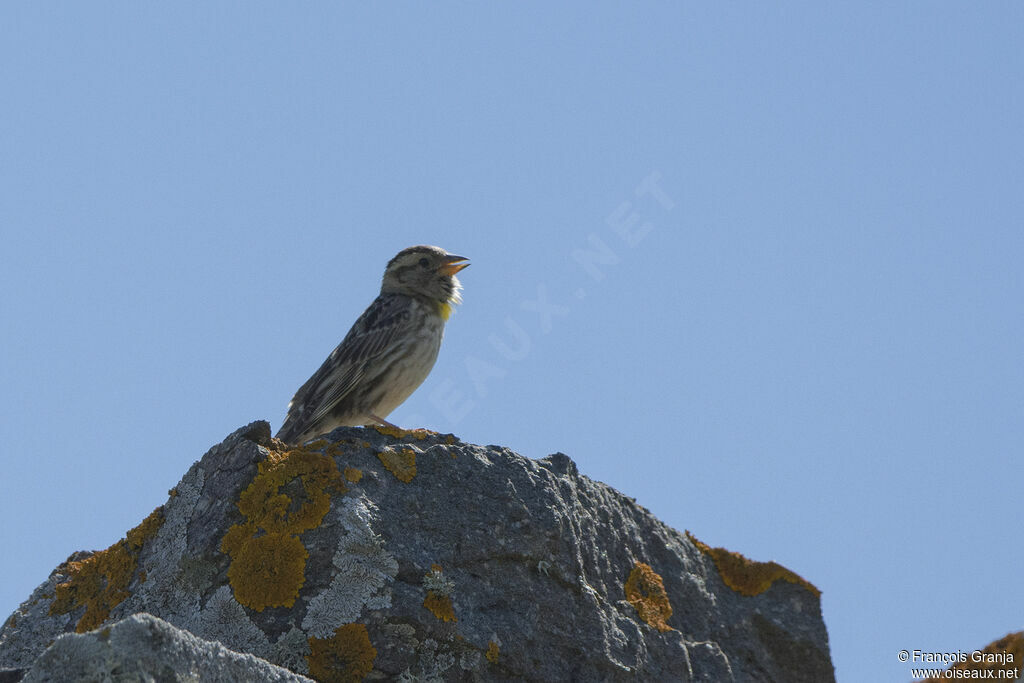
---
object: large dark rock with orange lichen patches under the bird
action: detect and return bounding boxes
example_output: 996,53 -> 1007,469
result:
0,422 -> 834,683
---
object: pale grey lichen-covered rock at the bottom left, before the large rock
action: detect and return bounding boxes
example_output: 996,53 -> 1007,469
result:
23,613 -> 310,683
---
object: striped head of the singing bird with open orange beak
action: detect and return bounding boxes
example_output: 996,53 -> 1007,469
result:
381,245 -> 469,317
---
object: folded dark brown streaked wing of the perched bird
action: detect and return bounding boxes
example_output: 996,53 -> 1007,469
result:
280,295 -> 413,440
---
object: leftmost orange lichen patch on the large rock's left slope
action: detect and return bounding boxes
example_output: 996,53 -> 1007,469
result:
49,507 -> 164,633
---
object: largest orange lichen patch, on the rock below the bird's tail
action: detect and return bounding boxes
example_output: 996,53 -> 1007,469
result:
220,441 -> 346,611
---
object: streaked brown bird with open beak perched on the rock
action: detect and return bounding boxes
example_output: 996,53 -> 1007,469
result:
276,245 -> 469,443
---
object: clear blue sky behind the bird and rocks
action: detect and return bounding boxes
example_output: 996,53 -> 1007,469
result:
0,1 -> 1024,682
